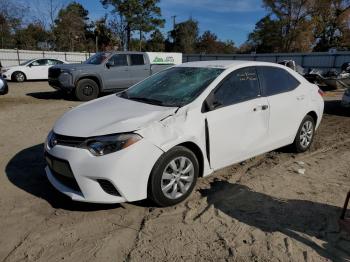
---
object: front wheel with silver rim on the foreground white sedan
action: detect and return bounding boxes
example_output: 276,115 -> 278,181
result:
148,146 -> 199,207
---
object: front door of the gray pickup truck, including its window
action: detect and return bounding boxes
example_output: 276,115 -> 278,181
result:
102,54 -> 130,89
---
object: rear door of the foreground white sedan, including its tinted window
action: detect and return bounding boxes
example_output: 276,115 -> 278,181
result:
258,66 -> 307,149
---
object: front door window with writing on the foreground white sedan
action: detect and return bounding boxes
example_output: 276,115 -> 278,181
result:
214,67 -> 260,106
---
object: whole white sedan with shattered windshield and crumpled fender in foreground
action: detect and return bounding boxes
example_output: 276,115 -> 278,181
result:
45,61 -> 324,206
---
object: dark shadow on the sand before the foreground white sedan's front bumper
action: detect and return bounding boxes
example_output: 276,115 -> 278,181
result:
5,144 -> 121,211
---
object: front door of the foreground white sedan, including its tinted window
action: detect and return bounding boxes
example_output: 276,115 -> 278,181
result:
205,67 -> 269,169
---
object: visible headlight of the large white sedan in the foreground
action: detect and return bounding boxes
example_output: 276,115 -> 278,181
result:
86,133 -> 142,156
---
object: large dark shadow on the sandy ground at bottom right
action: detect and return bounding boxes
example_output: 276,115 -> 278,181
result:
200,180 -> 350,261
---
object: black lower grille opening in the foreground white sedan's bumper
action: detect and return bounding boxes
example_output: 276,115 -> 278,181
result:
45,153 -> 81,192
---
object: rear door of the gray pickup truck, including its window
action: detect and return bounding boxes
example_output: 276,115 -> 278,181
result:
129,54 -> 151,85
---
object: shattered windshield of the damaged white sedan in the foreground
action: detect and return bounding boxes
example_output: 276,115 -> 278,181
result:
120,67 -> 224,107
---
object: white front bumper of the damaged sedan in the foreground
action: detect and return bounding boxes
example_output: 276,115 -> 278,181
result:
45,139 -> 163,203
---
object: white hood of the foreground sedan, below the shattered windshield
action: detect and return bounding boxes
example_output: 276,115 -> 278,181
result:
53,94 -> 177,137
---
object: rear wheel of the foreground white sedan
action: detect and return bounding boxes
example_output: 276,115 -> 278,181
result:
292,115 -> 315,153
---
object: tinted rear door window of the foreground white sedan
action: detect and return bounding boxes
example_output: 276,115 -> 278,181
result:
258,66 -> 300,96
